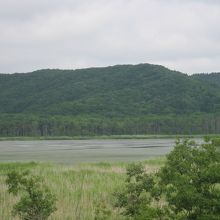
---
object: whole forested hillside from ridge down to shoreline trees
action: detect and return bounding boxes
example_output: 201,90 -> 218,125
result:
0,64 -> 220,136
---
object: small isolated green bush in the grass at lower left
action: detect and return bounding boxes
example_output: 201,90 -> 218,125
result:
6,171 -> 56,220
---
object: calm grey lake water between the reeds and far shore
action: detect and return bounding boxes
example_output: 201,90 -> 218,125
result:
0,139 -> 179,163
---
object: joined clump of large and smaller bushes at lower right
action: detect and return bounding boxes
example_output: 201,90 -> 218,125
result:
116,138 -> 220,220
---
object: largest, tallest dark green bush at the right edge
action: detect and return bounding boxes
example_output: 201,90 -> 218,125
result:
160,139 -> 220,219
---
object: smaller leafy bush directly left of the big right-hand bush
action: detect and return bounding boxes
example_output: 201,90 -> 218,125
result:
115,163 -> 166,220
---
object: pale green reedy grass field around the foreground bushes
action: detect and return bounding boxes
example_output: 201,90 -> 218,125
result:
0,157 -> 165,220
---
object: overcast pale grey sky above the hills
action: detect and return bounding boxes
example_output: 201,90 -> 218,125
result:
0,0 -> 220,74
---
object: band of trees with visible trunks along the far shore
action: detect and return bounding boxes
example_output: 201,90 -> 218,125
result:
0,114 -> 220,137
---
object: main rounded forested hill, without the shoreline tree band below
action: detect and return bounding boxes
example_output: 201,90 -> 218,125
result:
0,64 -> 220,116
